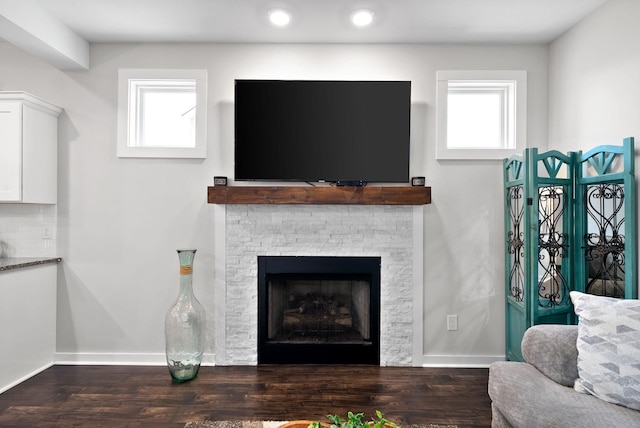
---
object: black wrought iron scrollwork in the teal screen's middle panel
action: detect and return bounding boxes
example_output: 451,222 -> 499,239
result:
538,186 -> 569,308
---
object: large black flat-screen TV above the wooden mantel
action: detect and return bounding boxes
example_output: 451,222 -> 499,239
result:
235,80 -> 411,183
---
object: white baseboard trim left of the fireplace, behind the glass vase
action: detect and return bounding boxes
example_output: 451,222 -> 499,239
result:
54,352 -> 215,366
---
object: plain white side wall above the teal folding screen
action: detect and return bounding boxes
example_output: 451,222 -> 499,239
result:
549,0 -> 640,300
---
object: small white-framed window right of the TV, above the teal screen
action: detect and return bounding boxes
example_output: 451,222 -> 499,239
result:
436,70 -> 527,159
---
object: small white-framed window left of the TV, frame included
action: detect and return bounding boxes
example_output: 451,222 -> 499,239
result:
118,69 -> 207,158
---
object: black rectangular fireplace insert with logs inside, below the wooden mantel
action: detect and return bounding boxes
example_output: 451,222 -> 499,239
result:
258,256 -> 381,365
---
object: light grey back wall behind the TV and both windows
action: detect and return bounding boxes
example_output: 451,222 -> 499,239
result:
0,43 -> 548,364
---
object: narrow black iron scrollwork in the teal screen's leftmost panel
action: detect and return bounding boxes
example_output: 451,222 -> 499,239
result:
507,186 -> 525,302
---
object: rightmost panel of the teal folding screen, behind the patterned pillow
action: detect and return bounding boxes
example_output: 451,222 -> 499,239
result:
575,142 -> 638,299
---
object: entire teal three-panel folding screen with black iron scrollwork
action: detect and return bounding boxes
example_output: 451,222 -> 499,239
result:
503,138 -> 637,361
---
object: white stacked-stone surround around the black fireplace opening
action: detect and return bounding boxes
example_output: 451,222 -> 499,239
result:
212,205 -> 423,366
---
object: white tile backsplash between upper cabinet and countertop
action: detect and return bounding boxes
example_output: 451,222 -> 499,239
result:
0,204 -> 58,257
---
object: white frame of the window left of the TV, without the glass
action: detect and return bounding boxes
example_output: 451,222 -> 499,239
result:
117,68 -> 207,159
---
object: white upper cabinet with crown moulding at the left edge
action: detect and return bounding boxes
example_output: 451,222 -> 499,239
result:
0,92 -> 62,204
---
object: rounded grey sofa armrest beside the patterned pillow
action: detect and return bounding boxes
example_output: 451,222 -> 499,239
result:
522,324 -> 578,387
